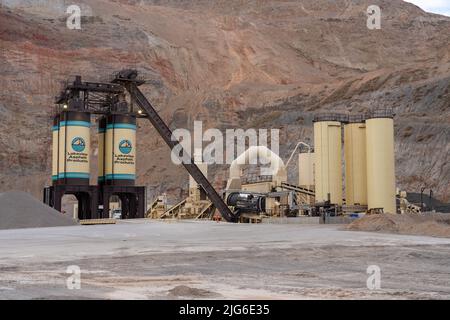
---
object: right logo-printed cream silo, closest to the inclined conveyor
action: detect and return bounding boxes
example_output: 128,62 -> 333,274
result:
104,114 -> 136,186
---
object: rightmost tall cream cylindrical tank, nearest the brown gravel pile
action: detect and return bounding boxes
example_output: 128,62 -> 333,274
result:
366,110 -> 397,213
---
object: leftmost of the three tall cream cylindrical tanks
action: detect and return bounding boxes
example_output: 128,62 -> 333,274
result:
314,114 -> 347,205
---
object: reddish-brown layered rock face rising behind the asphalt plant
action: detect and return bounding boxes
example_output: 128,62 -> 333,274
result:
0,0 -> 450,201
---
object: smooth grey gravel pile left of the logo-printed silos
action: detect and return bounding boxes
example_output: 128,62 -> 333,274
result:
0,191 -> 78,229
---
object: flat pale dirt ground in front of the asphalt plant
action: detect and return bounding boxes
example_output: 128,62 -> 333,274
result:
0,220 -> 450,299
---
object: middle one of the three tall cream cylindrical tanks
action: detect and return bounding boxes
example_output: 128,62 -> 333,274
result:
344,115 -> 367,205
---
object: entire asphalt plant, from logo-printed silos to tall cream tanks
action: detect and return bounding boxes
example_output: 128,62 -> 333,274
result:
44,70 -> 397,222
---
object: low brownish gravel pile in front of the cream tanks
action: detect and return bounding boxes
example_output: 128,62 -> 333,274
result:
347,213 -> 450,238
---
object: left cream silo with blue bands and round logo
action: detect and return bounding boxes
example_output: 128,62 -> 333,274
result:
57,111 -> 91,185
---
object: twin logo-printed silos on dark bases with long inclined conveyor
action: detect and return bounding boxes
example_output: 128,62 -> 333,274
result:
44,69 -> 236,222
